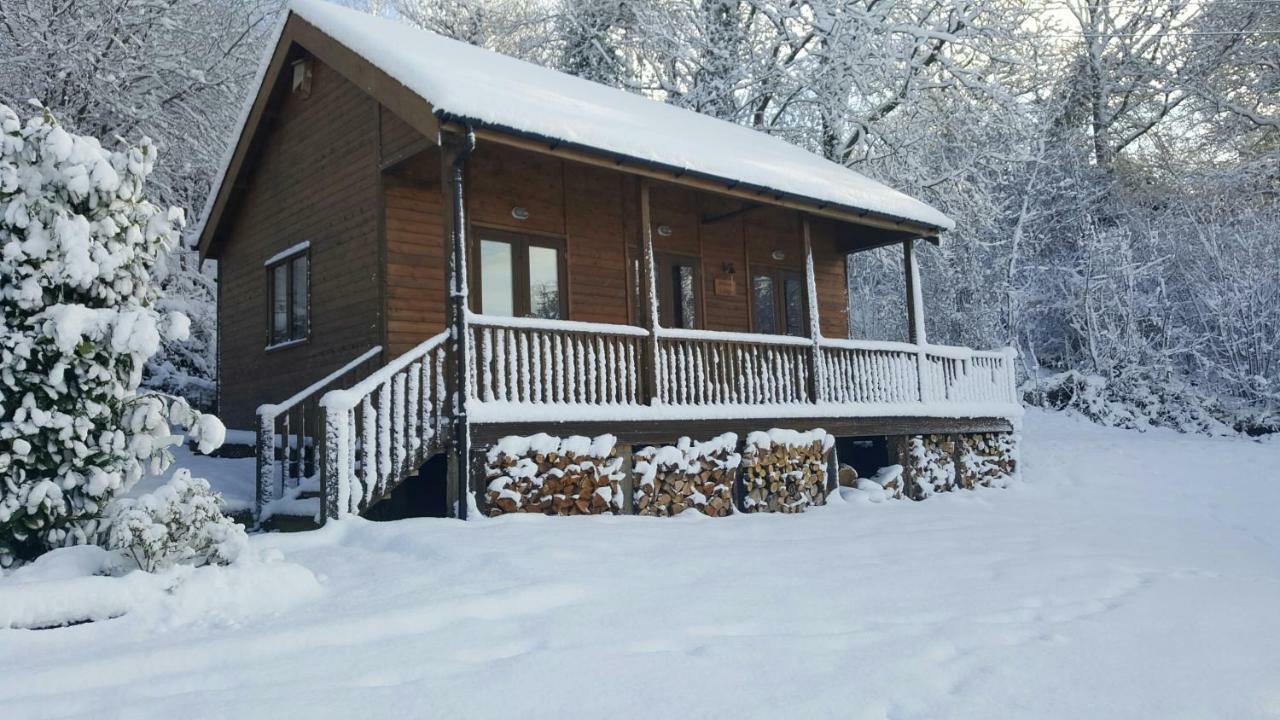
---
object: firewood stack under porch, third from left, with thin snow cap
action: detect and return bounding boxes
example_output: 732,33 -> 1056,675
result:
741,429 -> 836,512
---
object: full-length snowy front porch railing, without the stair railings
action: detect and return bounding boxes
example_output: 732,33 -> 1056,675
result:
470,315 -> 1018,419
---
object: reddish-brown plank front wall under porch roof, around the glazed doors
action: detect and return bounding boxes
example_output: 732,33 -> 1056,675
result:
467,143 -> 847,337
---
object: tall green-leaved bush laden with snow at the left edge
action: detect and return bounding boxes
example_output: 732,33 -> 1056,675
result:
0,105 -> 221,565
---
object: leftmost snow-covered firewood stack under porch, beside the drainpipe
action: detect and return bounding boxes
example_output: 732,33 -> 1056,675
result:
484,433 -> 622,516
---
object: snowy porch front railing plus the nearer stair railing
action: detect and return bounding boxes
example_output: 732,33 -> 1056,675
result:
303,315 -> 1018,519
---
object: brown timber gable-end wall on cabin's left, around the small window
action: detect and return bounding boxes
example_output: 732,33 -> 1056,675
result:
218,61 -> 381,428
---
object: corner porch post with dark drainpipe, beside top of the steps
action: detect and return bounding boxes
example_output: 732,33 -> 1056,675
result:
449,126 -> 476,520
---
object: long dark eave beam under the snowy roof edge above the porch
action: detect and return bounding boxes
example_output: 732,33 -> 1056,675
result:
442,122 -> 938,237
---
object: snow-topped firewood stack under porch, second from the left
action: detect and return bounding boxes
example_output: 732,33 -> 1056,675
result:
635,433 -> 741,518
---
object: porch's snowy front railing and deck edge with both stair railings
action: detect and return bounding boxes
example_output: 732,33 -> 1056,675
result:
249,307 -> 1020,519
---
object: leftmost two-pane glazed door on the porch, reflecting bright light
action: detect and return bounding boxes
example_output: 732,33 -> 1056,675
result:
474,228 -> 568,320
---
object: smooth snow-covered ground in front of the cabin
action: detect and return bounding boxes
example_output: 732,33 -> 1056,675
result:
0,413 -> 1280,720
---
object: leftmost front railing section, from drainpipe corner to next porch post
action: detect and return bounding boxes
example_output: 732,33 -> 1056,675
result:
468,315 -> 649,405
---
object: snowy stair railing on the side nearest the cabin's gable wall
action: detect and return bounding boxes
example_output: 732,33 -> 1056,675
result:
253,346 -> 383,520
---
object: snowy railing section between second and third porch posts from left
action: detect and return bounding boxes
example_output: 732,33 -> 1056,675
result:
657,329 -> 813,405
